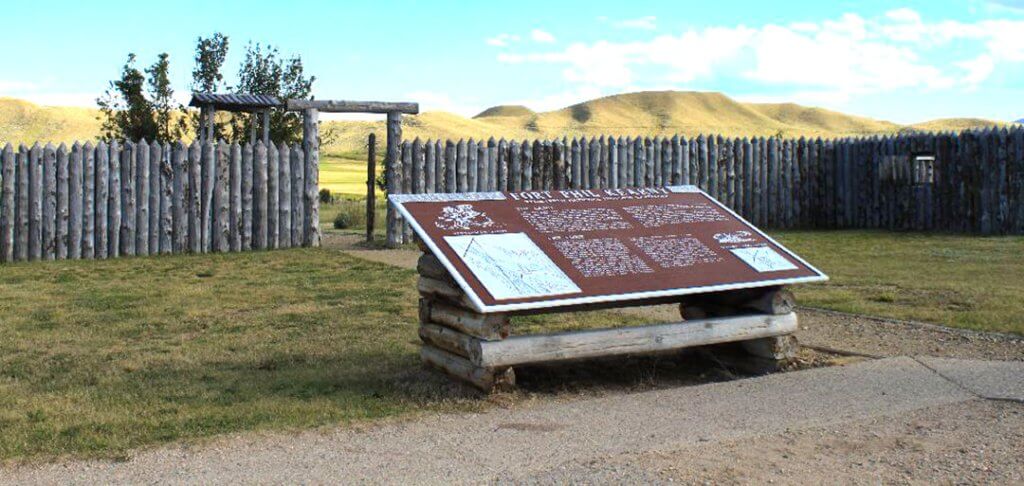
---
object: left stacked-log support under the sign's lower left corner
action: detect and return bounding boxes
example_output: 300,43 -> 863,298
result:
417,253 -> 515,392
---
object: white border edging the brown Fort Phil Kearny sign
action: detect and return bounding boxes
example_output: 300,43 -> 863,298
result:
388,185 -> 828,314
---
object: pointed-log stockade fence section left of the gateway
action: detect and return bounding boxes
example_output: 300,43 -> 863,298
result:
0,139 -> 319,262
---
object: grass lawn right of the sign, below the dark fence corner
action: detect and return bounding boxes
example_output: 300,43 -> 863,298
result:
773,231 -> 1024,335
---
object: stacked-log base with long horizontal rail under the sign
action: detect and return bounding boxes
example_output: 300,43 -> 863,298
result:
417,252 -> 798,392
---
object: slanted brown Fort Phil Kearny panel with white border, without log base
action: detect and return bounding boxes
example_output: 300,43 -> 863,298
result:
389,186 -> 828,312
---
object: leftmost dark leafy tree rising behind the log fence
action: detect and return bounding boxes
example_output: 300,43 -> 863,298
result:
96,53 -> 158,140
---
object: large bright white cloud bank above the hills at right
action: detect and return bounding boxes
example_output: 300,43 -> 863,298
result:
498,8 -> 1024,99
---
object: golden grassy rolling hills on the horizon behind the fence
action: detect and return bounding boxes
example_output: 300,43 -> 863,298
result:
0,91 -> 1000,153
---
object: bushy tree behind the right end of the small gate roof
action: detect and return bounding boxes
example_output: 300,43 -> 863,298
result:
231,43 -> 316,143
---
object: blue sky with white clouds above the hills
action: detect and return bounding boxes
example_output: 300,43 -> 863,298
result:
0,0 -> 1024,123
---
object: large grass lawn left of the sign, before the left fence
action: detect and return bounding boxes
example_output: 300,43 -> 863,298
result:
0,250 -> 640,461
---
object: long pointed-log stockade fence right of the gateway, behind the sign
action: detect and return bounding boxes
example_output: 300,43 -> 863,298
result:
386,127 -> 1024,246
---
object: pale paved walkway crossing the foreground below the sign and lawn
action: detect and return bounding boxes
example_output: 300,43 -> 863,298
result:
0,357 -> 1024,484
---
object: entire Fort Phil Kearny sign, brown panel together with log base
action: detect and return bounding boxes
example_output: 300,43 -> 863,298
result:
389,186 -> 827,391
